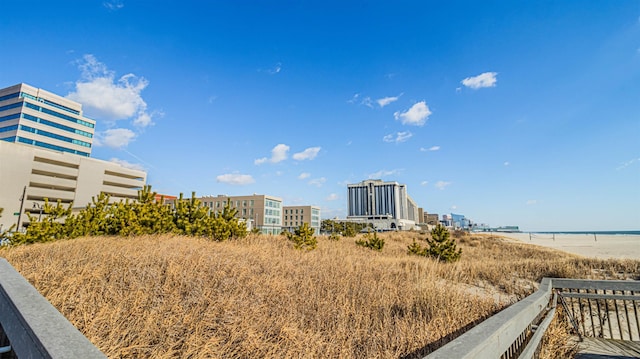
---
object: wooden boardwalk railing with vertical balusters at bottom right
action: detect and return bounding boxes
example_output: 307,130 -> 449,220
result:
425,278 -> 640,359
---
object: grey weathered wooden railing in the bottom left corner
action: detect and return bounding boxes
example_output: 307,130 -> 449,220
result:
0,258 -> 106,359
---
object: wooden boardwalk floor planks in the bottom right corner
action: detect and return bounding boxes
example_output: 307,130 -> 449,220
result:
575,338 -> 640,359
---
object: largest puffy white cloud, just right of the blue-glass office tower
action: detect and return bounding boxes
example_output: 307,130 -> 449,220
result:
67,55 -> 153,127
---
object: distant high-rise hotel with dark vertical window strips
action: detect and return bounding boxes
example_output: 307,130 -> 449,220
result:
347,180 -> 418,230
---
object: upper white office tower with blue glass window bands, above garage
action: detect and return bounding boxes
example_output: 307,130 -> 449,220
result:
0,84 -> 95,157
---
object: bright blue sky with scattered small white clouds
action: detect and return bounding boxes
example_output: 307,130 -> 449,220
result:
0,0 -> 640,231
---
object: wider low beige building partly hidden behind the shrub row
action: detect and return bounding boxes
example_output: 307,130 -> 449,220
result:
198,194 -> 283,234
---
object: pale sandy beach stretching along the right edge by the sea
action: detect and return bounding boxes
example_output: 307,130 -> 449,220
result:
493,233 -> 640,260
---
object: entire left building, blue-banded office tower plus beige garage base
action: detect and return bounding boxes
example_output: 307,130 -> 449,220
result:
0,84 -> 147,230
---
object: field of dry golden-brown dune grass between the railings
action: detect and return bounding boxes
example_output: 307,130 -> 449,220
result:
0,233 -> 640,358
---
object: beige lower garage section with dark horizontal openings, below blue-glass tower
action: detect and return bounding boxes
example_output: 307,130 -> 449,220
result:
0,141 -> 147,230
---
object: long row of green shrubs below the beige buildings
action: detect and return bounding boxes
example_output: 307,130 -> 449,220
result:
11,186 -> 247,244
